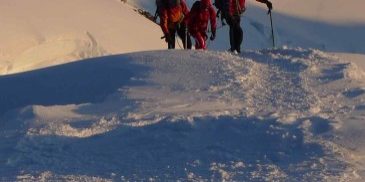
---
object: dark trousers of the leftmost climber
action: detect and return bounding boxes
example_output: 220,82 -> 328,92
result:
167,24 -> 191,49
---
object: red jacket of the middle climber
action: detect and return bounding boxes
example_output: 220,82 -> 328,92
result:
188,0 -> 217,33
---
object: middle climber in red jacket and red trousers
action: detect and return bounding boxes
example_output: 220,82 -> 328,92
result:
188,0 -> 217,49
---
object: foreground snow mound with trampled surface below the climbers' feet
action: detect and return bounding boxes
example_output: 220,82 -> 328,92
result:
0,48 -> 365,181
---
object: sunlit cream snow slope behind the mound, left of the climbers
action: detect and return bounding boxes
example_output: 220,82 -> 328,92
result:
0,0 -> 165,75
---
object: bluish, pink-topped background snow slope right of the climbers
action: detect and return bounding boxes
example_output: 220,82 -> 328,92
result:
132,0 -> 365,54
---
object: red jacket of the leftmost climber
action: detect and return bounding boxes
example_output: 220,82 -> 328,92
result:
159,0 -> 189,34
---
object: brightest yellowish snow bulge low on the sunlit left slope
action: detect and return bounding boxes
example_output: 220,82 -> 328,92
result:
0,32 -> 107,74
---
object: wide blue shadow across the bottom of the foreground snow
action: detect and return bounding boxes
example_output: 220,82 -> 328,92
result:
5,117 -> 346,181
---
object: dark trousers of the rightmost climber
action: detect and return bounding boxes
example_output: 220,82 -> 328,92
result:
226,15 -> 243,53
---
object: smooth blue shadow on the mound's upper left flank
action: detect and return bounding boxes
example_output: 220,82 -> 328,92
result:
0,55 -> 148,116
